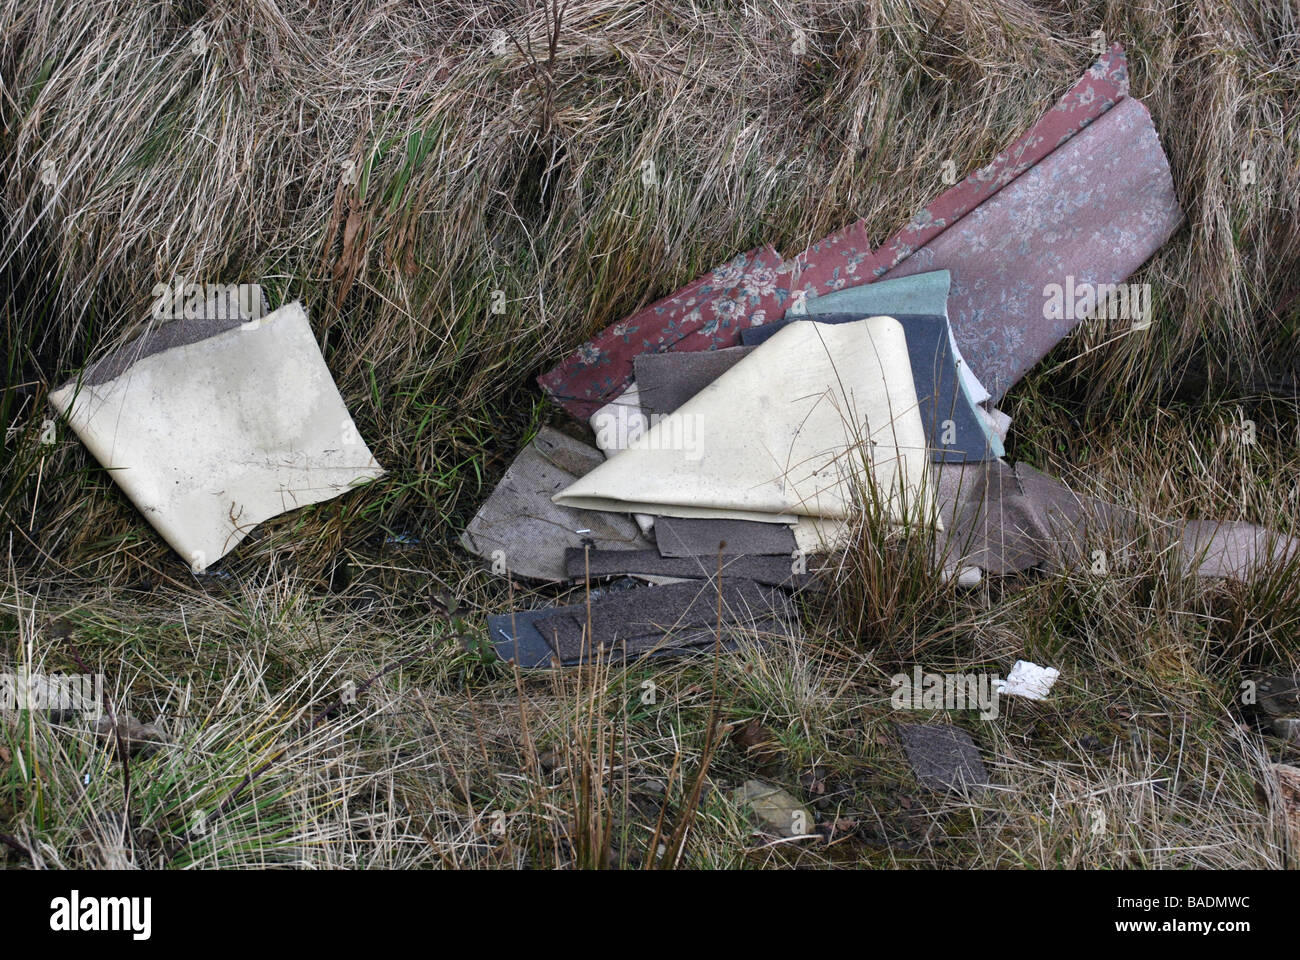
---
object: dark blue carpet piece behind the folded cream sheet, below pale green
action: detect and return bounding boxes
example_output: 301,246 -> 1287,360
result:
741,312 -> 1002,463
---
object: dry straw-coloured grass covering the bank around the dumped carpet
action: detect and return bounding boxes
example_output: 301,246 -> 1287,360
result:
0,0 -> 1300,866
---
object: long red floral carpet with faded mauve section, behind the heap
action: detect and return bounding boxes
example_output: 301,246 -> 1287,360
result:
538,44 -> 1182,419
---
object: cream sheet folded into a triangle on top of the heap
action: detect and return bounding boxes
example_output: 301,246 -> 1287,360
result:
555,317 -> 930,523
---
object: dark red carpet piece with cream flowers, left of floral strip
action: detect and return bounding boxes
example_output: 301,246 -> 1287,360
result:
537,246 -> 789,420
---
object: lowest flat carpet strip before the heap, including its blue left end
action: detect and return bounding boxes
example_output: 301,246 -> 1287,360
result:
488,576 -> 797,669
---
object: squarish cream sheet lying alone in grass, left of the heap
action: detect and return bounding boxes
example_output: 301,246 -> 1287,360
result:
49,303 -> 384,572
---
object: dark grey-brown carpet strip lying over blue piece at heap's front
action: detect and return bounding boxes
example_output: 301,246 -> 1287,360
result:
533,578 -> 794,663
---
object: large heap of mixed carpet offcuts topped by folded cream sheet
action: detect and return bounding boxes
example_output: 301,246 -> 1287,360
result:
462,44 -> 1295,667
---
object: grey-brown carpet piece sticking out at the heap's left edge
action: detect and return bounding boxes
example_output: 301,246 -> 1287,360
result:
460,427 -> 651,574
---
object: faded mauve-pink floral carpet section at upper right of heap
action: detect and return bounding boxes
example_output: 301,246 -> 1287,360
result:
885,99 -> 1183,399
